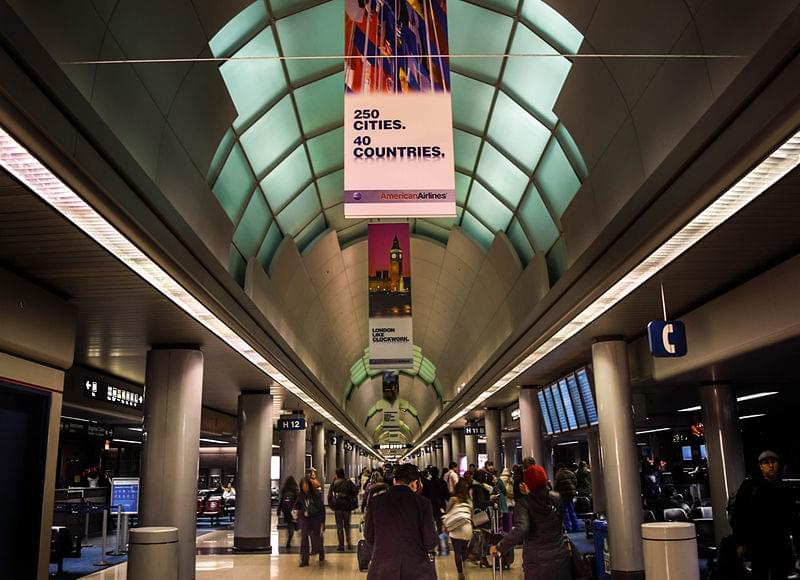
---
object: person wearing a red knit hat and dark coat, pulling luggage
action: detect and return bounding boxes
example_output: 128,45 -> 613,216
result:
489,465 -> 572,580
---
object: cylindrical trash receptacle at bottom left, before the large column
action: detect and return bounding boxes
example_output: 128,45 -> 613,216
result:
128,526 -> 178,580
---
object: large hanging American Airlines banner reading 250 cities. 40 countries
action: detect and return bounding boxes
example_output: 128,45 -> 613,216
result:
344,0 -> 456,218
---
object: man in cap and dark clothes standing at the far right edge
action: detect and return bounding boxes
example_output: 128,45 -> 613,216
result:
730,450 -> 800,580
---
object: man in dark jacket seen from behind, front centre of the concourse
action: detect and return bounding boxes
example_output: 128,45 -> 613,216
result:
364,463 -> 439,580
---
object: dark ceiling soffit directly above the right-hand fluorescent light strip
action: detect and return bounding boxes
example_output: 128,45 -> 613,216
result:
420,10 -> 800,440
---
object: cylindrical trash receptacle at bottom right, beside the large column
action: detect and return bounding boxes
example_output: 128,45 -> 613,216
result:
642,522 -> 700,580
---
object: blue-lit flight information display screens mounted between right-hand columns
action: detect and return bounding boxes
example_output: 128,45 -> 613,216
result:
538,368 -> 598,435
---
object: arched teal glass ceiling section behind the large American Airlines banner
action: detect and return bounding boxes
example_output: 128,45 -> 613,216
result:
208,0 -> 587,278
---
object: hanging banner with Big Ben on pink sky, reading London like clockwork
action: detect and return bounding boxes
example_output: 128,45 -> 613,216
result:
367,224 -> 414,369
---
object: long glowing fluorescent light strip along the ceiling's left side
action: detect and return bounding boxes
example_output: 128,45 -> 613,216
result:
0,128 -> 381,459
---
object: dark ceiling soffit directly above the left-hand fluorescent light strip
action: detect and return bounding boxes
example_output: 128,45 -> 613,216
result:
0,0 -> 367,437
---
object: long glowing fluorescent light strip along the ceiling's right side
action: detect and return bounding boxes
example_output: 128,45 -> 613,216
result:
406,132 -> 800,460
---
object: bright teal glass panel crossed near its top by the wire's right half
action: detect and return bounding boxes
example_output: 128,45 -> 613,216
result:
503,26 -> 572,128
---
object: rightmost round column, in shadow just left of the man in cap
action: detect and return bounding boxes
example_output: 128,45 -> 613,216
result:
700,383 -> 745,544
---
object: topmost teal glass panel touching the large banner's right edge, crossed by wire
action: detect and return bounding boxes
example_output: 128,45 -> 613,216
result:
447,1 -> 513,80
